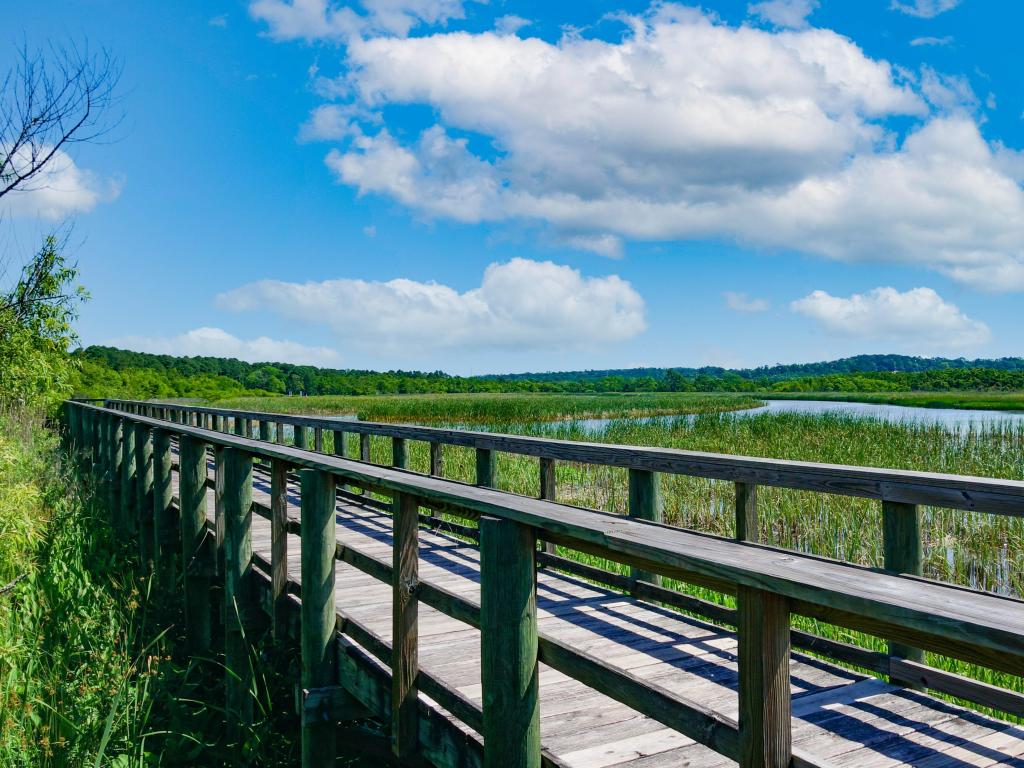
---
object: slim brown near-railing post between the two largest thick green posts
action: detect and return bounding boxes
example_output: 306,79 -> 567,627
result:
391,493 -> 420,758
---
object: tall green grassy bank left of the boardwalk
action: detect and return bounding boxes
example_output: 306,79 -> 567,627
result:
0,413 -> 307,768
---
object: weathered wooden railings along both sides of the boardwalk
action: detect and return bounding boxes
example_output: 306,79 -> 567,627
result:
67,400 -> 1024,766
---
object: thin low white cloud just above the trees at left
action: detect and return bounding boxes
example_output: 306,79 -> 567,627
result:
105,327 -> 339,366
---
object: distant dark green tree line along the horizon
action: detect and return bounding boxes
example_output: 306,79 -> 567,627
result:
75,346 -> 1024,399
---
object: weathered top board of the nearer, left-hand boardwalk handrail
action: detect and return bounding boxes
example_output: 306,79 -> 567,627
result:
77,403 -> 1024,674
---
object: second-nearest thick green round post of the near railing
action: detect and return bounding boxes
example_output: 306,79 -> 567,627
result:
299,469 -> 338,768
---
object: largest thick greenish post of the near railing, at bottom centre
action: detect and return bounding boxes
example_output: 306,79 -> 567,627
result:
480,517 -> 541,768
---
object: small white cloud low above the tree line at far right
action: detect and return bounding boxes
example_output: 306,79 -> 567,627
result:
790,288 -> 991,349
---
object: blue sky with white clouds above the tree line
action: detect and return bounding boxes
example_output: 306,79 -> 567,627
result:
8,0 -> 1024,373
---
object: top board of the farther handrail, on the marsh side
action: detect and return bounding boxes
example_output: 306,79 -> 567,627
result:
106,399 -> 1024,517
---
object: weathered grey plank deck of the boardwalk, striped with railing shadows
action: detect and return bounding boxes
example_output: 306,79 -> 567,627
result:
167,462 -> 1024,768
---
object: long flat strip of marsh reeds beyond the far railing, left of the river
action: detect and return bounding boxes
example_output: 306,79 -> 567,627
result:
213,392 -> 760,425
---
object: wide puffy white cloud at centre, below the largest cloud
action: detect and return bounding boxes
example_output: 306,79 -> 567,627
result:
217,258 -> 645,352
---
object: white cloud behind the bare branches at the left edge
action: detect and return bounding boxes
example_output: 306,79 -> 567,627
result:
0,147 -> 121,219
